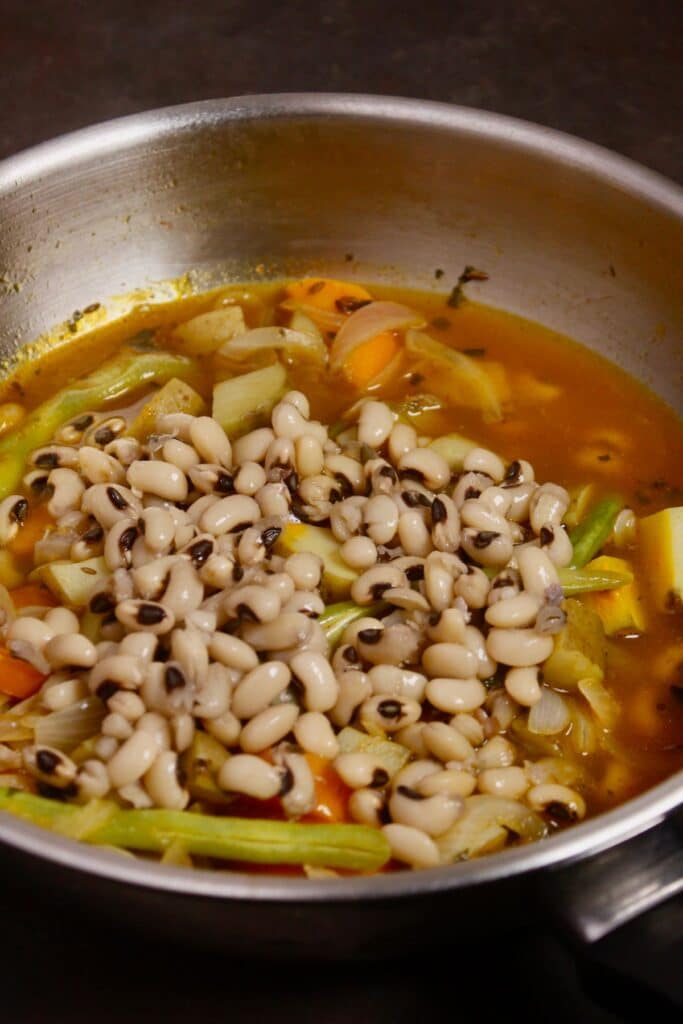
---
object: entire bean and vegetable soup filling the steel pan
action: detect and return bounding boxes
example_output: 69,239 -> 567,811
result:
0,276 -> 683,876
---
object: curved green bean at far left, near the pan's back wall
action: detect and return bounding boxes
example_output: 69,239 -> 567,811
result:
0,350 -> 193,499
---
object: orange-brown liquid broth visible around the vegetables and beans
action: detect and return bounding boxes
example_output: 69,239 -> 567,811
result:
0,272 -> 683,859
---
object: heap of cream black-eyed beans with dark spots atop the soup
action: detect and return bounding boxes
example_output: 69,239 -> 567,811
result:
0,391 -> 585,866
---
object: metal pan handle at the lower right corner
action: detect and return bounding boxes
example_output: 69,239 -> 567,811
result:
545,812 -> 683,943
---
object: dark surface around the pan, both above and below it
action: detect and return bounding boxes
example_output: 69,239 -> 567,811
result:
0,0 -> 683,1024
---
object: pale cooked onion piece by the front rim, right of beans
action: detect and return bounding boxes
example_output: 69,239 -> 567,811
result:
436,795 -> 548,863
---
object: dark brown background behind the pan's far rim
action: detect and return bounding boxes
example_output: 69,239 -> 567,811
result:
0,0 -> 683,179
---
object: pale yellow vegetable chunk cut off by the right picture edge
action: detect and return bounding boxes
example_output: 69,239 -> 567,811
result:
638,506 -> 683,611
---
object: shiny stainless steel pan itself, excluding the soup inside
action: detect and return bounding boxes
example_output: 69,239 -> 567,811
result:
0,94 -> 683,955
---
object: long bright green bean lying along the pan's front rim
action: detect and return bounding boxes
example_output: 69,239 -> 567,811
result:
0,788 -> 389,871
